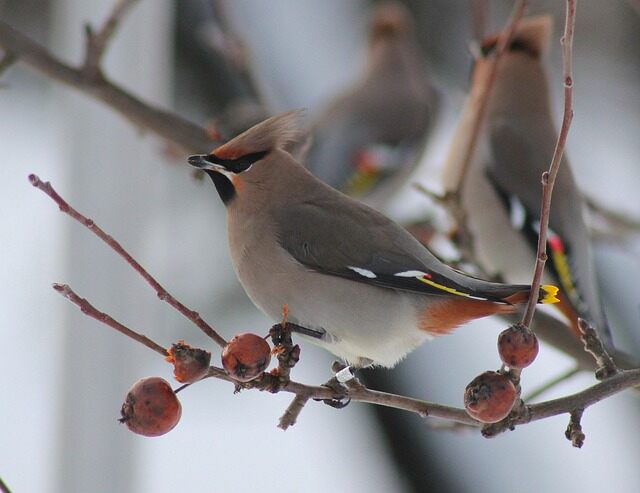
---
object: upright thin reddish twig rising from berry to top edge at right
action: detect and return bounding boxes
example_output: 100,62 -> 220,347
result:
522,0 -> 576,327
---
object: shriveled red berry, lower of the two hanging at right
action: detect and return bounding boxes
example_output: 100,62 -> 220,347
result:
464,371 -> 518,423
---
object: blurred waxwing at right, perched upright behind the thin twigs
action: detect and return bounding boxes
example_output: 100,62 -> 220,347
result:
443,16 -> 613,348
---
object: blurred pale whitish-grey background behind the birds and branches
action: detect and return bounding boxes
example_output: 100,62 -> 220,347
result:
0,0 -> 640,493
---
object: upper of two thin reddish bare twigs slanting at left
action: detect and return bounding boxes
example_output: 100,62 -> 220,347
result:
29,174 -> 227,347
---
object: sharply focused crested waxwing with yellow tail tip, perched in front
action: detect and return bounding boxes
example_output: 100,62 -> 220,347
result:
189,112 -> 557,367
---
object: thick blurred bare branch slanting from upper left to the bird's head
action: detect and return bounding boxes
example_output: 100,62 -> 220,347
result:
0,21 -> 215,152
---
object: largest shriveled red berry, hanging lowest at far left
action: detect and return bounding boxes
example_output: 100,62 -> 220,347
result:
119,377 -> 182,437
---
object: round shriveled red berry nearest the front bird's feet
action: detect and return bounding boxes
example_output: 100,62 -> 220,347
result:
222,332 -> 271,382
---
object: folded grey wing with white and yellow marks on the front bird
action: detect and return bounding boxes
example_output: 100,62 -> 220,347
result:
276,195 -> 529,301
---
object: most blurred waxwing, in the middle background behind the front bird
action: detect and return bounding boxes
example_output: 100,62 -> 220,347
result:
304,2 -> 438,202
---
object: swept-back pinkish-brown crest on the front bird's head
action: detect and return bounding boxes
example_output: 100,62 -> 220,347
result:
212,109 -> 304,160
